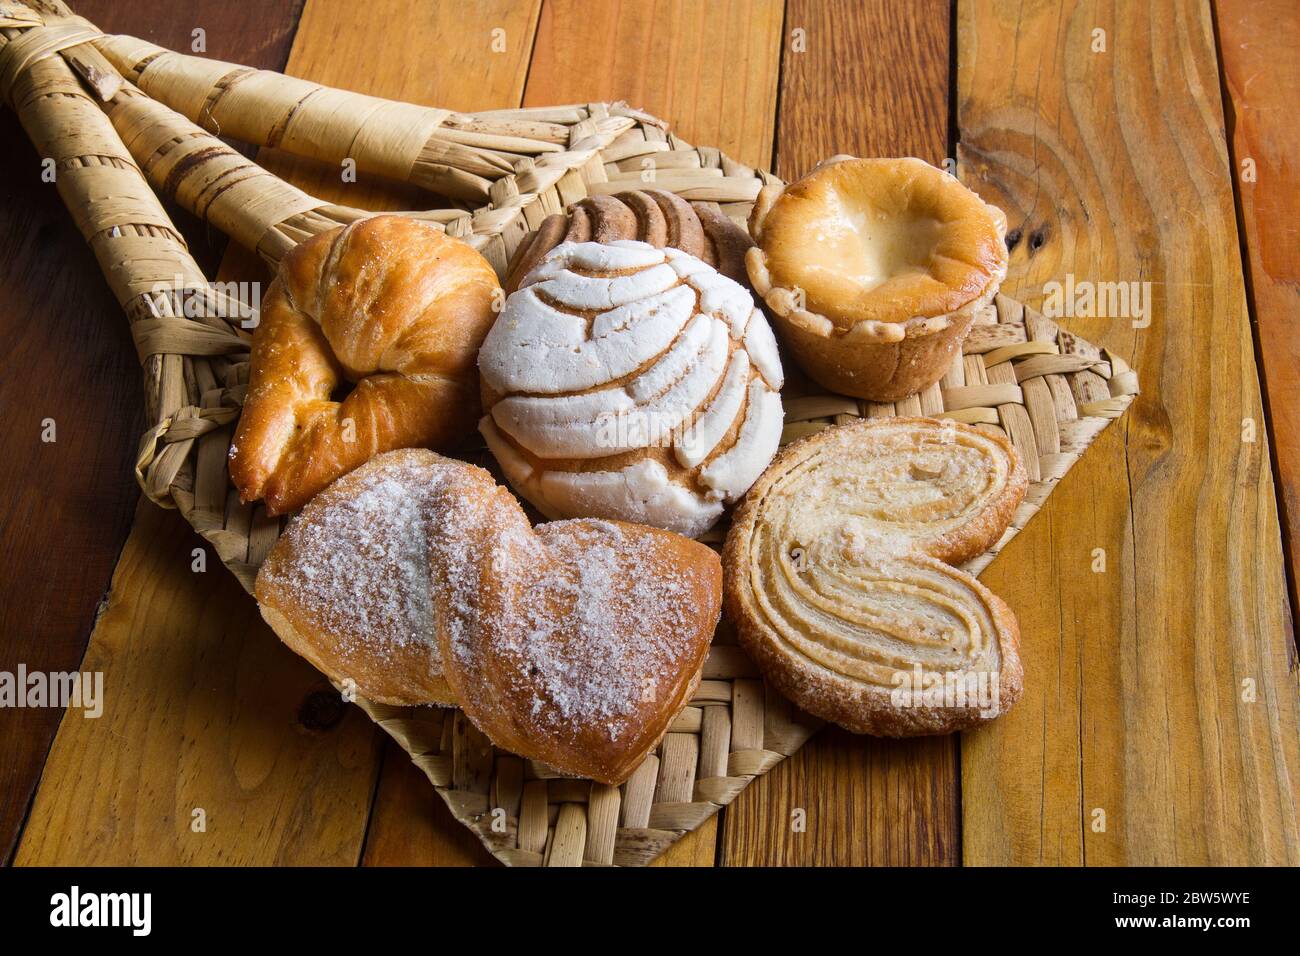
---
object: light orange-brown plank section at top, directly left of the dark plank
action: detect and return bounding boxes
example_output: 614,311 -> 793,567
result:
524,0 -> 781,169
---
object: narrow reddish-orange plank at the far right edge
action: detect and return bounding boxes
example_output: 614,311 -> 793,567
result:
1214,0 -> 1300,624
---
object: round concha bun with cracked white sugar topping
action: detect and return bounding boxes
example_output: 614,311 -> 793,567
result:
478,241 -> 784,536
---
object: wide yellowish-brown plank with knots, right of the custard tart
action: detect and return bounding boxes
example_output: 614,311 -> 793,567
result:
958,0 -> 1300,865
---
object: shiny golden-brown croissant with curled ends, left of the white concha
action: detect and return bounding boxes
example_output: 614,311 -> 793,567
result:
230,216 -> 501,515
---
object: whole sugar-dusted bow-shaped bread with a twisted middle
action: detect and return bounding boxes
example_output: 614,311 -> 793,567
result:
256,449 -> 722,783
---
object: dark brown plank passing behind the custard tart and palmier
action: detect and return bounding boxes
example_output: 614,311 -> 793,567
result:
722,0 -> 959,866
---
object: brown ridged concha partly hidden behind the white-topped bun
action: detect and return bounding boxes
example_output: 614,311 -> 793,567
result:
506,189 -> 754,293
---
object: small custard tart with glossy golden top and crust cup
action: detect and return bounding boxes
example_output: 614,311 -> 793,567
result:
746,157 -> 1008,402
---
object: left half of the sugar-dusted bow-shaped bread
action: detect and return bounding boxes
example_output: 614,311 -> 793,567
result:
254,449 -> 462,705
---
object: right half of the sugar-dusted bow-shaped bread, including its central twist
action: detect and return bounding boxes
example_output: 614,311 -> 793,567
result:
430,463 -> 722,783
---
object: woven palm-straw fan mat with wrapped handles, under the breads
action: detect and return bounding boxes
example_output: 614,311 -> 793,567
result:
0,0 -> 1138,866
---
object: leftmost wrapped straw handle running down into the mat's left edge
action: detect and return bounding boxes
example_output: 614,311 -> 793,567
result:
0,1 -> 271,587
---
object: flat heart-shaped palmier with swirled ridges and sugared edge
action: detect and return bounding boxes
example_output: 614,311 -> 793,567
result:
723,419 -> 1027,736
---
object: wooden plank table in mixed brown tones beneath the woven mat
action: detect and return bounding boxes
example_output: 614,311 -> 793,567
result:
0,0 -> 1300,865
